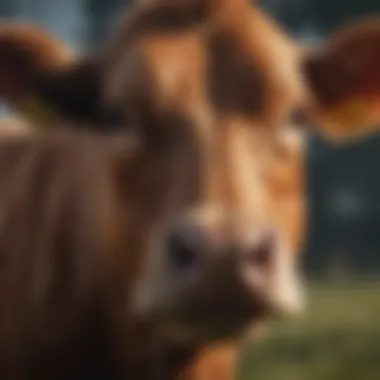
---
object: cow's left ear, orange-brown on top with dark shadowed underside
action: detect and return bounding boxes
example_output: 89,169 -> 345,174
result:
0,23 -> 121,129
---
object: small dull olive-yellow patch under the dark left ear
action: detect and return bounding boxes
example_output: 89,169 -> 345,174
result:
20,97 -> 58,128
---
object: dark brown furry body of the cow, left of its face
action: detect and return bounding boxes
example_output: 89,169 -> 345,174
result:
0,123 -> 202,379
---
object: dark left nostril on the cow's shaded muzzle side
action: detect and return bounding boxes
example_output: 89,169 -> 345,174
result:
167,227 -> 203,271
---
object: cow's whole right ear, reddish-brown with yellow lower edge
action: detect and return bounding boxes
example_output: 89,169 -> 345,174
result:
303,19 -> 380,141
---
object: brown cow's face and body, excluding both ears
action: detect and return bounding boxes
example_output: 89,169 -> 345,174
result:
0,0 -> 304,379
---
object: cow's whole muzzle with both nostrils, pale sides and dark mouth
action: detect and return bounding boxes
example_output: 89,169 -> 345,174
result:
133,217 -> 304,341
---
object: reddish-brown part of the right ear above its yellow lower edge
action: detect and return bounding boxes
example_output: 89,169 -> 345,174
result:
304,19 -> 380,108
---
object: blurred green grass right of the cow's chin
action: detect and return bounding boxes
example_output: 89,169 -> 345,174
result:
240,281 -> 380,380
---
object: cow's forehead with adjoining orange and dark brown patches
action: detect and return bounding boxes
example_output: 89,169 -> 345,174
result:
119,31 -> 274,134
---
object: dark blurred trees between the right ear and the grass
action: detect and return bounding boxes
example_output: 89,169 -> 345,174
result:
305,133 -> 380,273
